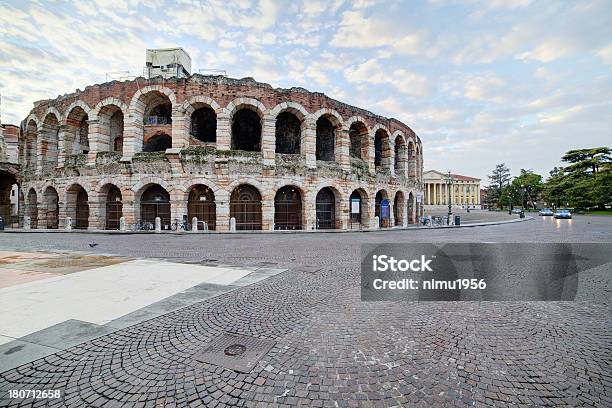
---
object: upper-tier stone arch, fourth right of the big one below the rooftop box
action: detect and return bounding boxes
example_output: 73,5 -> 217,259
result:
310,108 -> 343,162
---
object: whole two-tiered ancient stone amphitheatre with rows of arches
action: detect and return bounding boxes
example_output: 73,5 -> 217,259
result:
15,74 -> 423,231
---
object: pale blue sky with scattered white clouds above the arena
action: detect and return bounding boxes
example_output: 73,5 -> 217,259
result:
0,0 -> 612,184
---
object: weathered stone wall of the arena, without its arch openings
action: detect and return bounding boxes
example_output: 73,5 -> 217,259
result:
19,75 -> 423,230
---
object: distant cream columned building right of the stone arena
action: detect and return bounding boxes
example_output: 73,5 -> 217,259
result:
423,170 -> 481,211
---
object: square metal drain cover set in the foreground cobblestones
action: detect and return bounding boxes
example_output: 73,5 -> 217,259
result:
195,333 -> 275,373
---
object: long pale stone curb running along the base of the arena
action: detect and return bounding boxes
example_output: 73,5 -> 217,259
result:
0,216 -> 534,235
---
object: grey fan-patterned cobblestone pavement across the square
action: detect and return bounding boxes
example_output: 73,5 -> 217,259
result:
0,217 -> 612,407
